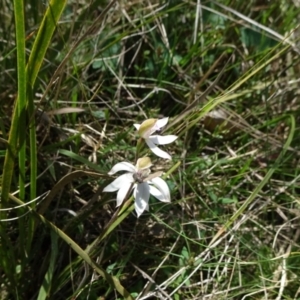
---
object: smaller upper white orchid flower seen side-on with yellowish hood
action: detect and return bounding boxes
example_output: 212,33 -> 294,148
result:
134,118 -> 177,159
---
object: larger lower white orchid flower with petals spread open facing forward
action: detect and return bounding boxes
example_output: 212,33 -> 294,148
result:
103,157 -> 171,217
